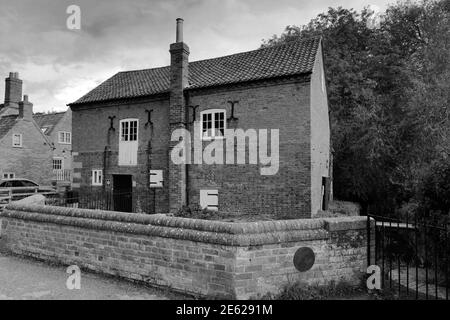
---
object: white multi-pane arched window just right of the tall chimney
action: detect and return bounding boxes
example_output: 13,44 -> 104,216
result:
200,109 -> 227,140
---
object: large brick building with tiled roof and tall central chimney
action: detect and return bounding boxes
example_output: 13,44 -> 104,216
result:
70,19 -> 330,217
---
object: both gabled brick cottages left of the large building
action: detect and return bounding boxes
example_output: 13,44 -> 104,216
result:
0,72 -> 72,186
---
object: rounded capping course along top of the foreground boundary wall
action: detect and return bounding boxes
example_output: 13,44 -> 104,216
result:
1,203 -> 338,246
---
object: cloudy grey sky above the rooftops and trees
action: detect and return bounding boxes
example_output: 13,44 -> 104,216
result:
0,0 -> 392,112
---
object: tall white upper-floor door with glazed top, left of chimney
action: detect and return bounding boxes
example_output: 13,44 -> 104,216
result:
119,119 -> 139,166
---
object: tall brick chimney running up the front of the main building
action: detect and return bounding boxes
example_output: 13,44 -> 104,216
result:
169,18 -> 189,212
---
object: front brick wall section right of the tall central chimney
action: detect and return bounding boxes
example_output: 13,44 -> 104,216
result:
188,77 -> 311,218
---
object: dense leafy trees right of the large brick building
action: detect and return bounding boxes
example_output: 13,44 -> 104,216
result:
262,0 -> 450,218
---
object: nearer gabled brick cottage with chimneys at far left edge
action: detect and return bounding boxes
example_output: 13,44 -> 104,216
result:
0,72 -> 53,185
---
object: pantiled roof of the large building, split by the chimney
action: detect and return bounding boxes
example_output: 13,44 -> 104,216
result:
71,37 -> 320,105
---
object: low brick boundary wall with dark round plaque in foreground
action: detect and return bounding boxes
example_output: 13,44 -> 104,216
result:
0,202 -> 373,299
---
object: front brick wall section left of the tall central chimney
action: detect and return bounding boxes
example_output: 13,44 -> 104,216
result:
72,98 -> 169,212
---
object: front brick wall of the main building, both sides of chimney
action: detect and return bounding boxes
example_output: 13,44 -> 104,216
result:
73,78 -> 311,218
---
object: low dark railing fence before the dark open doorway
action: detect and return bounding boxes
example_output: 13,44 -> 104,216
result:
46,190 -> 156,214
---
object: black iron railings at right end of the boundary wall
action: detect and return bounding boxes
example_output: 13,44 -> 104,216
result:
367,214 -> 450,300
